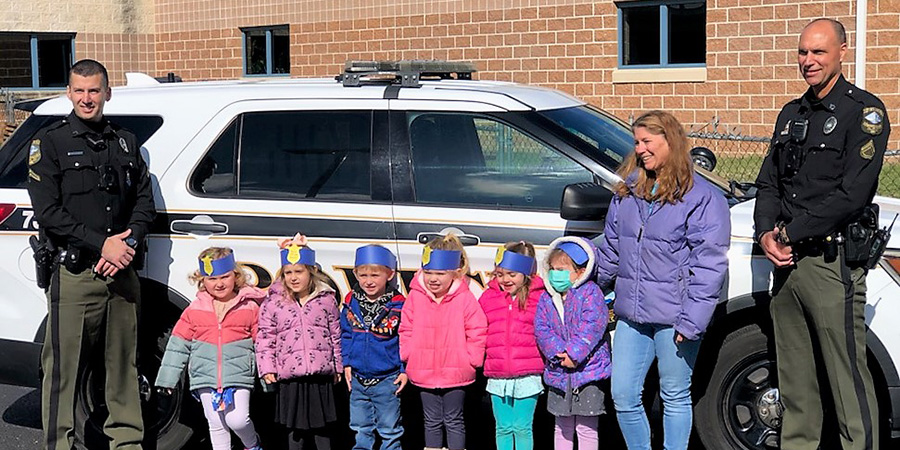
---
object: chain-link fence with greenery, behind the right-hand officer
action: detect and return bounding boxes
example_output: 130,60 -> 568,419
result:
687,122 -> 900,198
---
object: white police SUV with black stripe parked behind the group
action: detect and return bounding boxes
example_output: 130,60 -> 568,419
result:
0,62 -> 900,450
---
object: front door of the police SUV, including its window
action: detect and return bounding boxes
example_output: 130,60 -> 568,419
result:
391,101 -> 602,292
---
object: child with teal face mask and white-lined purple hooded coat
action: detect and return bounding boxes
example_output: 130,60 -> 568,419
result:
534,237 -> 610,450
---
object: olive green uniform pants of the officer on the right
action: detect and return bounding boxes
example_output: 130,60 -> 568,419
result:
770,252 -> 878,450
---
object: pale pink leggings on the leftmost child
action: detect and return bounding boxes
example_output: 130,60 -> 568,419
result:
199,388 -> 257,450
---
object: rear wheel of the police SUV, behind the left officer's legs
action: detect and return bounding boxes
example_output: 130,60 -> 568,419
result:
75,321 -> 203,450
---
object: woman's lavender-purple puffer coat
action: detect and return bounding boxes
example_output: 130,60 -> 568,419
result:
597,173 -> 731,340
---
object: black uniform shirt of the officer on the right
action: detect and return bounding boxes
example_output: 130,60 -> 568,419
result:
754,75 -> 891,242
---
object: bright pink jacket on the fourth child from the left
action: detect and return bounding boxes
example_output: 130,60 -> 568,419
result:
400,270 -> 487,389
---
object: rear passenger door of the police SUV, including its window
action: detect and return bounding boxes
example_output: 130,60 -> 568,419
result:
157,100 -> 396,298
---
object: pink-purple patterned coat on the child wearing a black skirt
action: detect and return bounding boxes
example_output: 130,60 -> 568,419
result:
256,278 -> 344,380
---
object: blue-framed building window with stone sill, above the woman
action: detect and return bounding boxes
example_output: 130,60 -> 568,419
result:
616,0 -> 706,68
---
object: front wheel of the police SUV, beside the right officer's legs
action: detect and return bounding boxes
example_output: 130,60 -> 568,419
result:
695,325 -> 782,450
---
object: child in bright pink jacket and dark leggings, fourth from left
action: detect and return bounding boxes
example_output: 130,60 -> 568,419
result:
400,234 -> 487,450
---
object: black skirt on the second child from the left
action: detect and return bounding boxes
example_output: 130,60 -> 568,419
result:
275,375 -> 337,430
